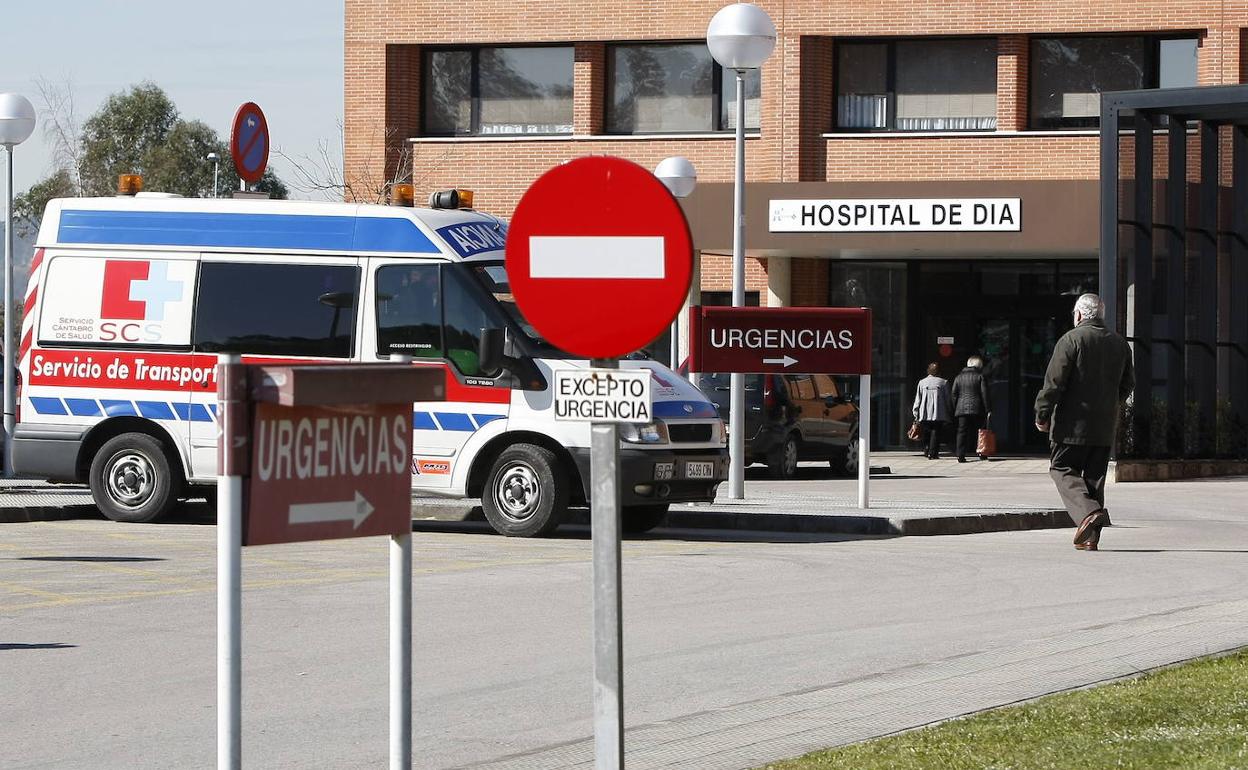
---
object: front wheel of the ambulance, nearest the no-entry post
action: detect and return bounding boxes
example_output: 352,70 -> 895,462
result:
480,444 -> 569,538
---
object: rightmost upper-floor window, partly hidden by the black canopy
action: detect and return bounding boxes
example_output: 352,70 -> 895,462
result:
1031,35 -> 1197,129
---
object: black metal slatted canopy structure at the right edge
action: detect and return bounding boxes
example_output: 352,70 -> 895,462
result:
1101,85 -> 1248,457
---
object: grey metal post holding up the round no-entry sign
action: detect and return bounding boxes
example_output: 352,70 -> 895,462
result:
589,359 -> 624,770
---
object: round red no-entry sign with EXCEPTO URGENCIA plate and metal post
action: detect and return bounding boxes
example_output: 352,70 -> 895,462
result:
507,156 -> 693,770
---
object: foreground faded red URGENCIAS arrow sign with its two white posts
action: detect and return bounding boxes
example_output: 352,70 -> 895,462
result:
217,354 -> 446,770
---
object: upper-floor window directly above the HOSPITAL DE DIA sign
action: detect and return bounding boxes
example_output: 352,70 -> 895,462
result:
835,37 -> 997,131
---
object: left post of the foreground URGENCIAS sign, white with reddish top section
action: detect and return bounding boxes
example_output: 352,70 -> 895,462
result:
217,353 -> 251,770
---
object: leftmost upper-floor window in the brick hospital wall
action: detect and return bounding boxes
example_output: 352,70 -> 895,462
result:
422,46 -> 573,136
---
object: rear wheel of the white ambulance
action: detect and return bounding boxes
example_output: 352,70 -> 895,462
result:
91,433 -> 182,523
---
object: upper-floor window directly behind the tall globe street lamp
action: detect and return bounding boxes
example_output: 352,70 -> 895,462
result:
607,42 -> 761,134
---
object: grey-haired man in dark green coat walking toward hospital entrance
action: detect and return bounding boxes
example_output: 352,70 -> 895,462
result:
1036,295 -> 1136,550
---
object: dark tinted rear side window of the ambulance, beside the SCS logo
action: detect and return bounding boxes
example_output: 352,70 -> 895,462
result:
192,262 -> 359,358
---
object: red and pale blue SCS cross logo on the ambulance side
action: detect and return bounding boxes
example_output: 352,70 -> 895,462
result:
100,260 -> 186,342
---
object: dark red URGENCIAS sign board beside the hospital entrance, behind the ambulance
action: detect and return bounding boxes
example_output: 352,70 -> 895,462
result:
689,307 -> 871,374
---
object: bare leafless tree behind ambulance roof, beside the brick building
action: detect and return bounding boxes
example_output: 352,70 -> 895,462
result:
273,120 -> 449,203
